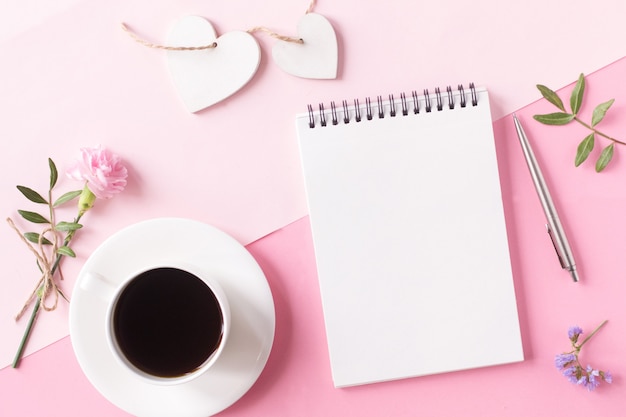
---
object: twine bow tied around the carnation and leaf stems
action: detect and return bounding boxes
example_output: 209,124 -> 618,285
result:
7,218 -> 59,321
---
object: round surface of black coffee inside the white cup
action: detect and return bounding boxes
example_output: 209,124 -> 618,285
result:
113,268 -> 223,377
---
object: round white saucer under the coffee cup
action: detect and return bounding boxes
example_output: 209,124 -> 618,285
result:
70,218 -> 276,417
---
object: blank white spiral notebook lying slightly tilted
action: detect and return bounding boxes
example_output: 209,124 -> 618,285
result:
296,85 -> 523,387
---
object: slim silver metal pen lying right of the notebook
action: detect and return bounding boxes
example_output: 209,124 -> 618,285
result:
513,114 -> 578,282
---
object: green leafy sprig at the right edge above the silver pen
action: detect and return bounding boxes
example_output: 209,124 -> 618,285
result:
533,74 -> 626,172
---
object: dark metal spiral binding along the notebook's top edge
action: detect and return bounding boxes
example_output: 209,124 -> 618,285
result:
307,83 -> 478,129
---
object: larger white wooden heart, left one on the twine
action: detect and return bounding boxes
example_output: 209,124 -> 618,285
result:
167,16 -> 261,112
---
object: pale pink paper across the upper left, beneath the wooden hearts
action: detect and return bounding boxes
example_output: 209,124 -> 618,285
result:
0,0 -> 626,366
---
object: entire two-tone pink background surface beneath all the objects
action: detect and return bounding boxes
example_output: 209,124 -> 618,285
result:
0,0 -> 626,416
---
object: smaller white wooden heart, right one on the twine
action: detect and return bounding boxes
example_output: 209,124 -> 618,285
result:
272,13 -> 338,79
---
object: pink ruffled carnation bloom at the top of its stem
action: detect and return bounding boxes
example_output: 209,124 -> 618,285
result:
67,145 -> 128,199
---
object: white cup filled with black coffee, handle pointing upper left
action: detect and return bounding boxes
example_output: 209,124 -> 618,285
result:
80,261 -> 231,385
